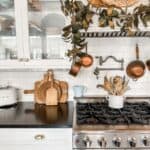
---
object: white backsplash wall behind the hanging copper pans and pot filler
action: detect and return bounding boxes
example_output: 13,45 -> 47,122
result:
0,38 -> 150,101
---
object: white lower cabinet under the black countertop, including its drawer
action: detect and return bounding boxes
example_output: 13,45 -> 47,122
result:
0,128 -> 72,150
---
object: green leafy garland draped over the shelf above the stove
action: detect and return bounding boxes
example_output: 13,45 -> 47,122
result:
60,0 -> 150,59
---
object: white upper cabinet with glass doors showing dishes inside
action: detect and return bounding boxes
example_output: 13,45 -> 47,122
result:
0,0 -> 70,69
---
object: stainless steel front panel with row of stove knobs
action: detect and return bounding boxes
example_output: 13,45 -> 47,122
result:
73,132 -> 150,150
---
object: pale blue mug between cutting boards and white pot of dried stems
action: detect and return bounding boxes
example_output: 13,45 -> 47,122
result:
73,85 -> 87,97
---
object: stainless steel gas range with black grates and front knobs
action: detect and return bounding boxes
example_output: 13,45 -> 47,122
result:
73,97 -> 150,150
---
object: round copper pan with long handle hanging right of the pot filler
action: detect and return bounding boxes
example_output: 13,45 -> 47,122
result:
126,44 -> 145,80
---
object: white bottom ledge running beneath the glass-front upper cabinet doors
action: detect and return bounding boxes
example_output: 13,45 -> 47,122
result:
0,59 -> 71,71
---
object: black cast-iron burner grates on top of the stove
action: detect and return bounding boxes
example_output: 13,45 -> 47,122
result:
76,102 -> 150,125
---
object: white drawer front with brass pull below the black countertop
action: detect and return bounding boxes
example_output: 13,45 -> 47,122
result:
0,128 -> 72,146
